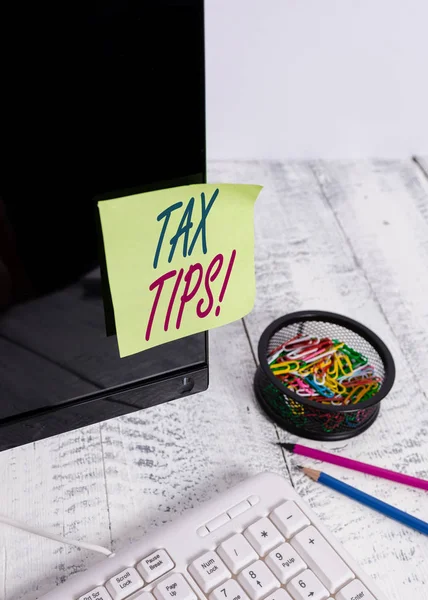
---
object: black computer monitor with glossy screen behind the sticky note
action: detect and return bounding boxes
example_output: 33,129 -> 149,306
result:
0,0 -> 208,449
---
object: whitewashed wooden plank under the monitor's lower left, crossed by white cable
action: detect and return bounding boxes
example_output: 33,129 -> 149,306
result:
0,425 -> 110,600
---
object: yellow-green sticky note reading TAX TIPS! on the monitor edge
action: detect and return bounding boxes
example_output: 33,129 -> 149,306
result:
98,183 -> 261,357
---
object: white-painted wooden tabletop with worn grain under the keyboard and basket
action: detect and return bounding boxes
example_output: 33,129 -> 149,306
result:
0,159 -> 428,600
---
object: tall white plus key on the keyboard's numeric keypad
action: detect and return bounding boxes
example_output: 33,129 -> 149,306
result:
291,525 -> 354,594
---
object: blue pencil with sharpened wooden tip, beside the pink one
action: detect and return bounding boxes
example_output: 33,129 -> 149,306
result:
300,467 -> 428,535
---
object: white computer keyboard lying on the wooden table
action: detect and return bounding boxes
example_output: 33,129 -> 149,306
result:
39,473 -> 387,600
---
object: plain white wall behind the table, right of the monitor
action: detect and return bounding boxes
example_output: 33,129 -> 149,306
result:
205,0 -> 428,159
